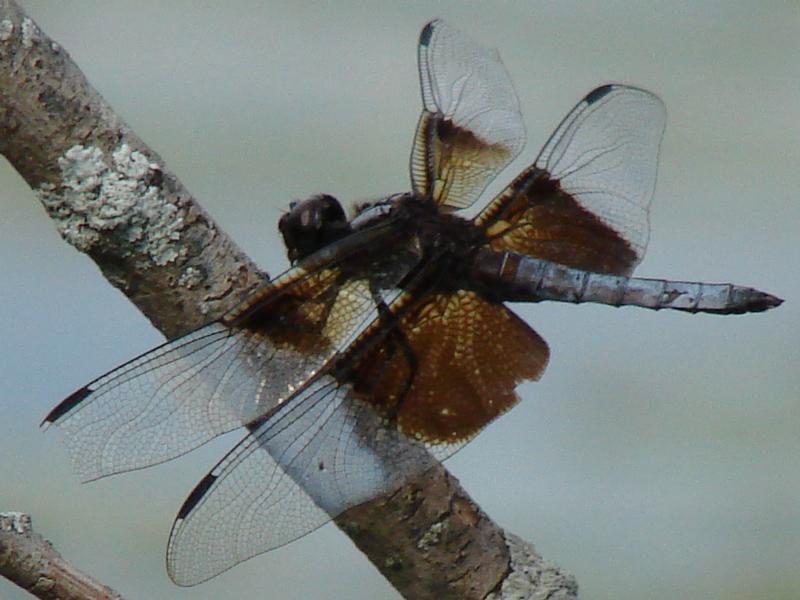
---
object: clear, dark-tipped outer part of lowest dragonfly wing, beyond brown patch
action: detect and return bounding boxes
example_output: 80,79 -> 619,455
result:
167,376 -> 444,585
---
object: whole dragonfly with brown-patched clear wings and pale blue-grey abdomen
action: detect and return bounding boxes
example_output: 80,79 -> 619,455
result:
44,20 -> 780,585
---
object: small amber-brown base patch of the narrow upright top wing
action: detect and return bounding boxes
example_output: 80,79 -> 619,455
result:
411,111 -> 514,208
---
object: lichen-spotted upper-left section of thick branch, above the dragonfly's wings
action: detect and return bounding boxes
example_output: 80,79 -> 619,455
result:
0,2 -> 264,338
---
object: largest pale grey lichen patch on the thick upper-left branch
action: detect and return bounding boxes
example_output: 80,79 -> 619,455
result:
37,144 -> 184,266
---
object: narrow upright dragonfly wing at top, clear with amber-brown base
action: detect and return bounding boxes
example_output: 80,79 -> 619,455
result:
411,20 -> 525,208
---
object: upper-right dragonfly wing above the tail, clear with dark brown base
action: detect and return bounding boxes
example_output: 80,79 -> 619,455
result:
476,85 -> 666,274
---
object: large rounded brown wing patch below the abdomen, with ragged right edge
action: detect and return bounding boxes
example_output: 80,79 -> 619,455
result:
353,291 -> 549,444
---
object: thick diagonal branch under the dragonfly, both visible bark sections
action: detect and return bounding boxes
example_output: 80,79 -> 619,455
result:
0,0 -> 577,599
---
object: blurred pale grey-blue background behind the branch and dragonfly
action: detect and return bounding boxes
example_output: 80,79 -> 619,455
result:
0,0 -> 800,600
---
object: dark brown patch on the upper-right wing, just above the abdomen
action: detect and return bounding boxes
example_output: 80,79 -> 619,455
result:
475,167 -> 639,275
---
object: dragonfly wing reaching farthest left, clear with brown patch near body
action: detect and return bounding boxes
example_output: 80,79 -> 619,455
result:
45,265 -> 390,481
